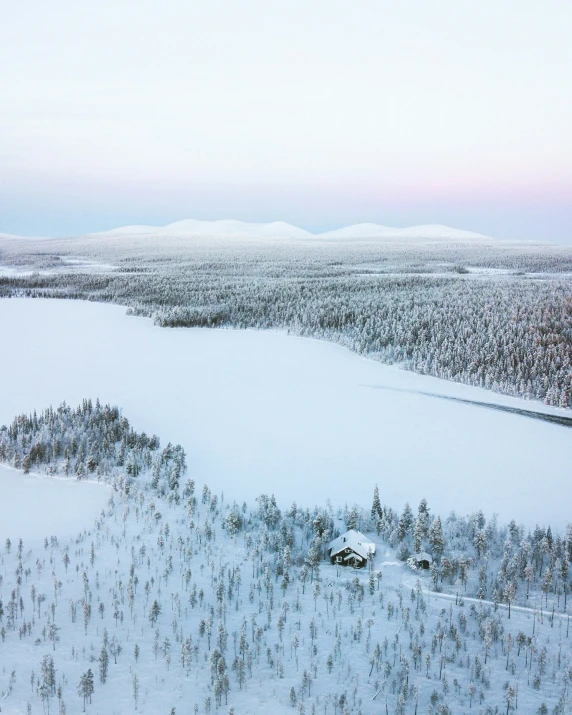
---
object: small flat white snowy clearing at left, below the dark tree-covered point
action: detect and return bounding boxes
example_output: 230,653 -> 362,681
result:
0,465 -> 110,548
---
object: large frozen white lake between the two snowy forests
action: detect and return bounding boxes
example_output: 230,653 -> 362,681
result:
0,299 -> 572,530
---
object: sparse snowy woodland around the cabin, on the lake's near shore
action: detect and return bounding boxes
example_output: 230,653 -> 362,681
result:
0,399 -> 572,715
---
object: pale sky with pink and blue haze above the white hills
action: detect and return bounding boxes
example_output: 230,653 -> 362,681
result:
0,0 -> 572,244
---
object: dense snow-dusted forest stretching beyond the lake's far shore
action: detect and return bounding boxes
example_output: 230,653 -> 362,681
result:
0,236 -> 572,407
